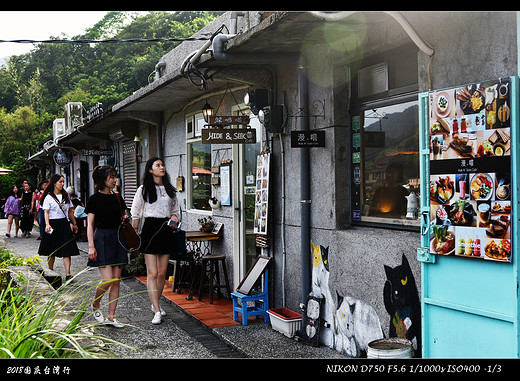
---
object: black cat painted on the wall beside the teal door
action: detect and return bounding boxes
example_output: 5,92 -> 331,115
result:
383,254 -> 421,357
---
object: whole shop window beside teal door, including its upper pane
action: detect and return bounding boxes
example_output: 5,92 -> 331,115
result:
351,46 -> 420,229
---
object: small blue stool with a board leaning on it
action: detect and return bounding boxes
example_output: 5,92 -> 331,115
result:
231,269 -> 269,325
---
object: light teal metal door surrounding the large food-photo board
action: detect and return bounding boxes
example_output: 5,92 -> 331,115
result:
417,77 -> 520,358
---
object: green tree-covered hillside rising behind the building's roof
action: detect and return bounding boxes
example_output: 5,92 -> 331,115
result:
0,11 -> 222,193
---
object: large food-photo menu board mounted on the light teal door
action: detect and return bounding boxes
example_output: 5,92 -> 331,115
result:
428,78 -> 513,262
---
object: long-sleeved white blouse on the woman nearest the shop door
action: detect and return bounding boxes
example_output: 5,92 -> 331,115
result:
130,185 -> 181,221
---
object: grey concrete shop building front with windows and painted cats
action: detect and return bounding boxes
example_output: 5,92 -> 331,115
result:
27,12 -> 518,357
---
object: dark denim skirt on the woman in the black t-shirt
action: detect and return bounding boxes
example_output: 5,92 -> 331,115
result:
87,228 -> 128,267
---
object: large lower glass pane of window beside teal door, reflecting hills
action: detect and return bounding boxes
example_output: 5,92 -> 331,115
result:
353,101 -> 419,225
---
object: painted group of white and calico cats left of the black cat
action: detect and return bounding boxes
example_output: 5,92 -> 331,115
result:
311,243 -> 384,357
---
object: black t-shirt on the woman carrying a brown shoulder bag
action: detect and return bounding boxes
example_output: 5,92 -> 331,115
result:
85,192 -> 126,229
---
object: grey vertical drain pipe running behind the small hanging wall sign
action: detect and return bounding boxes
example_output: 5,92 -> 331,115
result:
298,57 -> 312,304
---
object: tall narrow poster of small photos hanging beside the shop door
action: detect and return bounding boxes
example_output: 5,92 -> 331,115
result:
254,153 -> 271,235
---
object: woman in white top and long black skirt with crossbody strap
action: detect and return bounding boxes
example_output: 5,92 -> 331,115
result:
38,174 -> 79,280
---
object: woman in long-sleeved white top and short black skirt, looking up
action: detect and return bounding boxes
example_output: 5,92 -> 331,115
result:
131,157 -> 180,324
